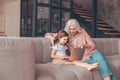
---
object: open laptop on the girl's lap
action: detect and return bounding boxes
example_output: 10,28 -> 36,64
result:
69,48 -> 85,61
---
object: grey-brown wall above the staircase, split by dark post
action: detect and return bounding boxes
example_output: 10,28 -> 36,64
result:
74,0 -> 120,31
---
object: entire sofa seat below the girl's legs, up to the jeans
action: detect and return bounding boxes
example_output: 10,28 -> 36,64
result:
36,63 -> 101,80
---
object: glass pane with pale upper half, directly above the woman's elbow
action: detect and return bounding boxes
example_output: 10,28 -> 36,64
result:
37,6 -> 49,36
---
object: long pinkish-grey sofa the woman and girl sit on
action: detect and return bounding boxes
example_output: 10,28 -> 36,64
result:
0,37 -> 120,80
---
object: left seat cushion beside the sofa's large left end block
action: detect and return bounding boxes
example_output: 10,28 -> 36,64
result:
36,64 -> 78,80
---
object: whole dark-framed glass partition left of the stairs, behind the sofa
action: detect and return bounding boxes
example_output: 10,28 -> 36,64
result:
20,0 -> 71,37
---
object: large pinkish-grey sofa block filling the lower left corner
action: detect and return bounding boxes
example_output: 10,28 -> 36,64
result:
0,38 -> 35,80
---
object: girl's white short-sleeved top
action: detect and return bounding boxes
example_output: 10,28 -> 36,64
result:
52,44 -> 68,56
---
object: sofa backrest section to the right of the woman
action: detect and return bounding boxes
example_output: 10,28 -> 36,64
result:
93,38 -> 120,56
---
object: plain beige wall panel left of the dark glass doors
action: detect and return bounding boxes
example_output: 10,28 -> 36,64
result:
4,0 -> 20,36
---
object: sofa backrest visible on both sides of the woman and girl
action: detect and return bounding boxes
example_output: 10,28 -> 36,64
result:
31,37 -> 120,63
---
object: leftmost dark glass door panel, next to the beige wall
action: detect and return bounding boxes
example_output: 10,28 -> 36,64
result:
20,0 -> 33,37
